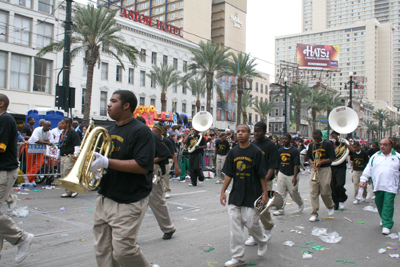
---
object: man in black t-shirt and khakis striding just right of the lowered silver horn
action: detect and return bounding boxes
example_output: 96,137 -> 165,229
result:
273,134 -> 304,215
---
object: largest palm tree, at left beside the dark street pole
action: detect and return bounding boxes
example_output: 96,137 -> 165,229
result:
37,5 -> 141,124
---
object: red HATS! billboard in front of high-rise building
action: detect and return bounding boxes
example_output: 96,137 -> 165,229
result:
297,44 -> 339,70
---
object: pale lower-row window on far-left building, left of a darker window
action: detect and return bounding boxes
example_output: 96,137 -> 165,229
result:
10,54 -> 30,91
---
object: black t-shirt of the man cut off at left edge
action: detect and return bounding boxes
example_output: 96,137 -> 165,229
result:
0,112 -> 18,171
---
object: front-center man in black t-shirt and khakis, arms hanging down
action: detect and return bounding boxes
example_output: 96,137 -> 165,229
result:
220,124 -> 268,266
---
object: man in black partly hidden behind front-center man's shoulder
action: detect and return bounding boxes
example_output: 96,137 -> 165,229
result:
245,121 -> 278,246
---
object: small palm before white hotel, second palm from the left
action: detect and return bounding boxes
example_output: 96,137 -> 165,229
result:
147,64 -> 181,111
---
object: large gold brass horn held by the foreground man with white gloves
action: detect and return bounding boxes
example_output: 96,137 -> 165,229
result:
55,127 -> 111,194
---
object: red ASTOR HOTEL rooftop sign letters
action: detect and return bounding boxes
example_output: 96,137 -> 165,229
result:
120,8 -> 183,37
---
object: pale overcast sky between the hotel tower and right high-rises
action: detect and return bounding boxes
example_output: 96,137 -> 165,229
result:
246,0 -> 301,82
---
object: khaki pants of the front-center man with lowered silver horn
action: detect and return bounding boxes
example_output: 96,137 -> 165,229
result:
228,205 -> 268,260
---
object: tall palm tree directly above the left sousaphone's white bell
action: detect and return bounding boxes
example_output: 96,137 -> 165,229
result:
185,41 -> 228,112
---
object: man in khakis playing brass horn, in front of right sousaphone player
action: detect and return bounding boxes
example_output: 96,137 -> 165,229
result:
307,130 -> 336,222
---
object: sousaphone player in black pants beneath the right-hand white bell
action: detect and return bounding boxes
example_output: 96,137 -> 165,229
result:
331,131 -> 354,210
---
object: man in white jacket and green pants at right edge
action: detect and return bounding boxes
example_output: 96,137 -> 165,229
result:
360,138 -> 400,235
